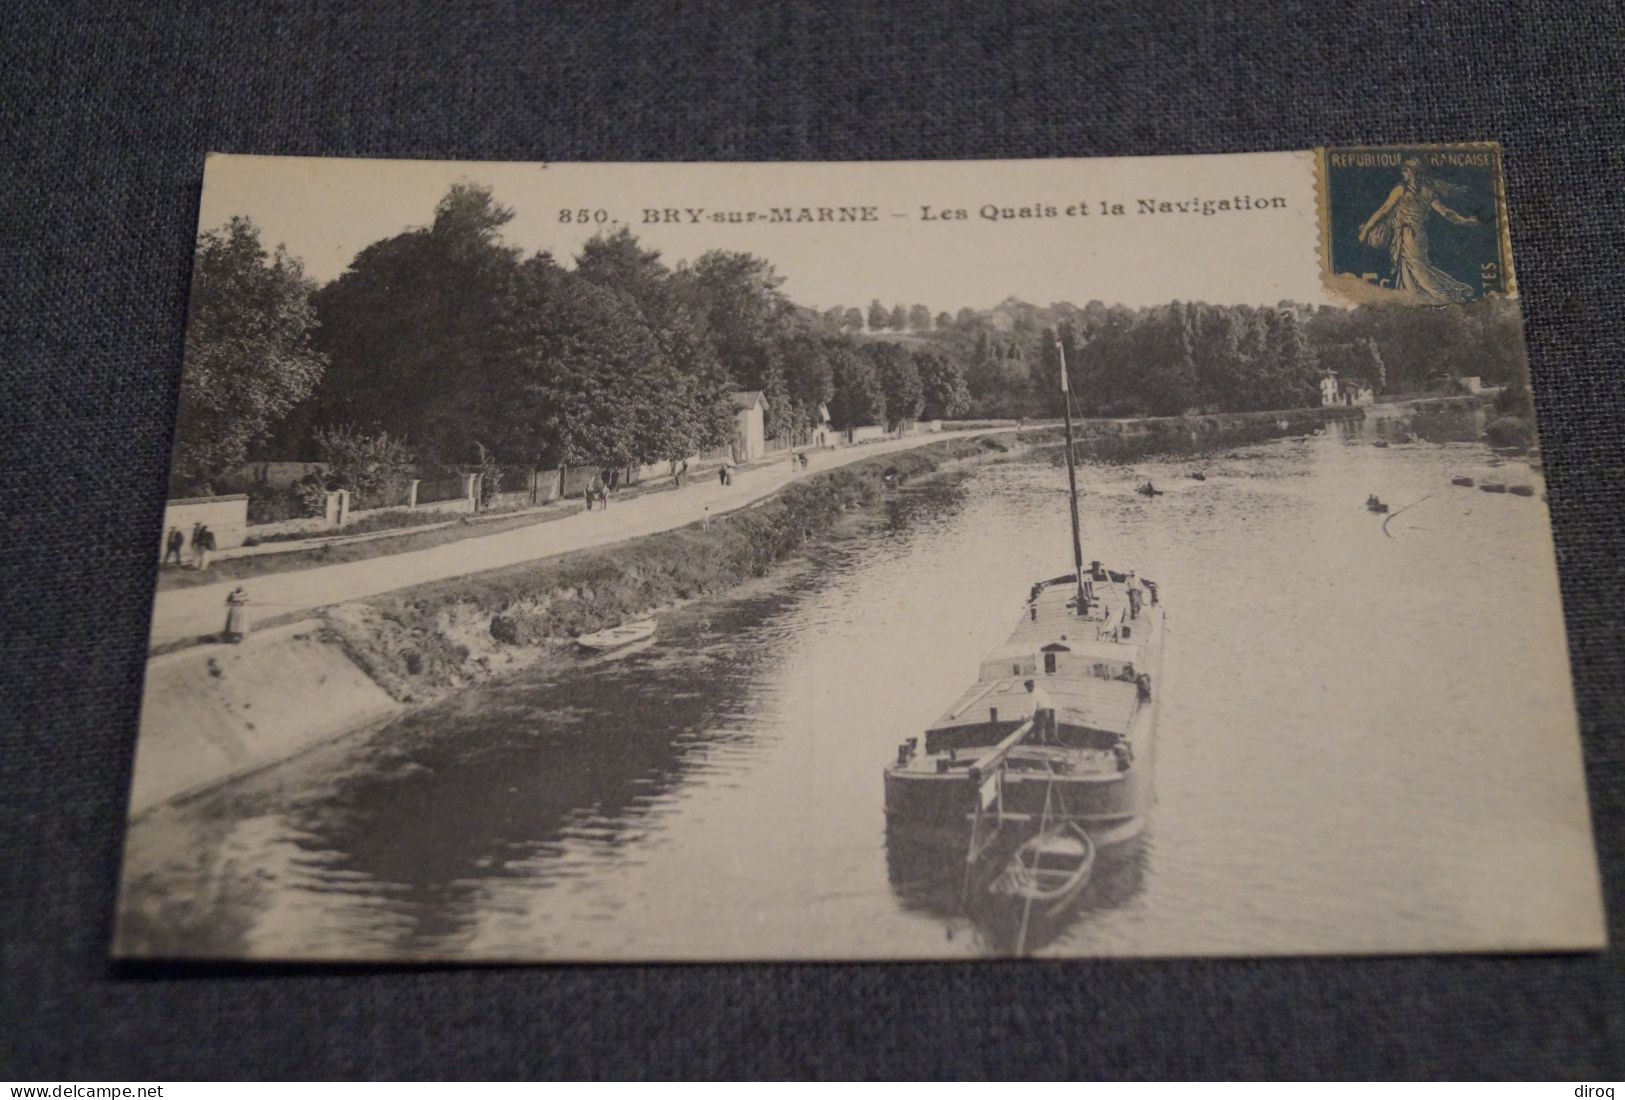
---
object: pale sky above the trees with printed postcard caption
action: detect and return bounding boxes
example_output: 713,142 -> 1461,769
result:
198,153 -> 1331,312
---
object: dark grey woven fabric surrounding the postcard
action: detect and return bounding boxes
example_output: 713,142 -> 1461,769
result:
0,0 -> 1625,1081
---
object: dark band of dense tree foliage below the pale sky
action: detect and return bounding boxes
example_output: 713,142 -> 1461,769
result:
176,184 -> 1528,486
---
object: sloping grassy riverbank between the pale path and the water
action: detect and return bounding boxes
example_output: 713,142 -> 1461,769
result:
132,408 -> 1362,814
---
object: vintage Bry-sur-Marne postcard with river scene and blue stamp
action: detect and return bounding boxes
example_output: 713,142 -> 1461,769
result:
115,145 -> 1606,962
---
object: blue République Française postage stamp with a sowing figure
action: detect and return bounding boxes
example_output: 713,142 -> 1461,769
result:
1320,143 -> 1516,305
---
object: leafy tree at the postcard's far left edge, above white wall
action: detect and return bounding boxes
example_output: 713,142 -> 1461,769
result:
171,218 -> 327,492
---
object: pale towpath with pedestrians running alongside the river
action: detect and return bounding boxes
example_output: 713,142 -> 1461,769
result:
148,427 -> 1011,647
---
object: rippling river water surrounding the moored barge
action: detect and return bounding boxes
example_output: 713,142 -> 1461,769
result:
120,419 -> 1599,959
